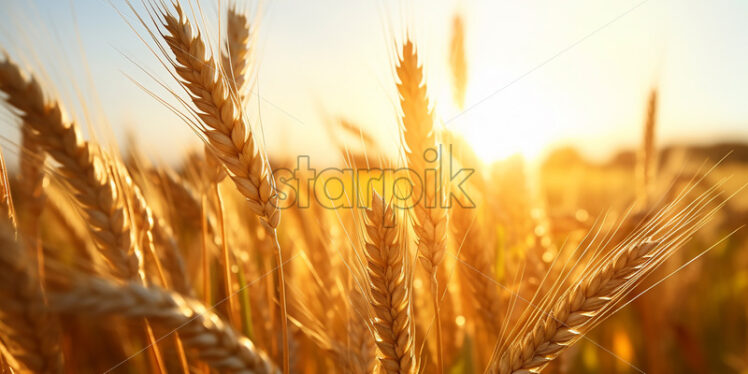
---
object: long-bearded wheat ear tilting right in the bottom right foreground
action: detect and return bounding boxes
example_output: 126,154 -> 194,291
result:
489,182 -> 724,374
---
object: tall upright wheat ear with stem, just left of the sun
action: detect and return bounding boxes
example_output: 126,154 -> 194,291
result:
395,40 -> 447,372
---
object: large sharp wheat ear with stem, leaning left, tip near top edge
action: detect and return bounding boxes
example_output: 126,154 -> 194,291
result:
152,2 -> 289,373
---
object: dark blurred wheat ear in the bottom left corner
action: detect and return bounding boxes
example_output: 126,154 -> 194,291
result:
0,223 -> 62,373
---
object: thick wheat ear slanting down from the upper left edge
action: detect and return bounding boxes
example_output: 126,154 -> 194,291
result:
0,59 -> 141,278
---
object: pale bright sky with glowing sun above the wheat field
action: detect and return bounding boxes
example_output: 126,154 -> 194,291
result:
0,0 -> 748,165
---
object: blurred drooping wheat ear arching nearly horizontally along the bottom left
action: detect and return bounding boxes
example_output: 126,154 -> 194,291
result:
49,278 -> 278,374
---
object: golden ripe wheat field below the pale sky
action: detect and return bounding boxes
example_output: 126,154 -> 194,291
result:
0,0 -> 748,374
